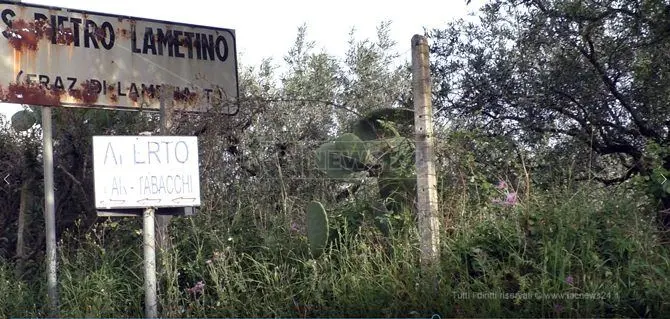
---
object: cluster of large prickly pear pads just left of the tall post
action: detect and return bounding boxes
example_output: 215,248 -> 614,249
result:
310,108 -> 416,243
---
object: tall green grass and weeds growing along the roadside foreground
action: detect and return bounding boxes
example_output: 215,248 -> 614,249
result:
0,181 -> 670,317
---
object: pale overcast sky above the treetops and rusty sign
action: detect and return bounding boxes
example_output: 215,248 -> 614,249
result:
0,0 -> 483,117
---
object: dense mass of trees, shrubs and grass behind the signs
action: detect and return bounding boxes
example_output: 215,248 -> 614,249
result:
0,0 -> 670,317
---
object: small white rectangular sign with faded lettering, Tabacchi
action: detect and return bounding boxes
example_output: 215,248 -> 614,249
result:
93,136 -> 200,209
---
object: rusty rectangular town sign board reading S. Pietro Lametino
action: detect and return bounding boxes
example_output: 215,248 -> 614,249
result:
0,0 -> 239,114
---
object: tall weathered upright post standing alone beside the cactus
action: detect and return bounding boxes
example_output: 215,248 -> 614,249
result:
412,34 -> 440,270
